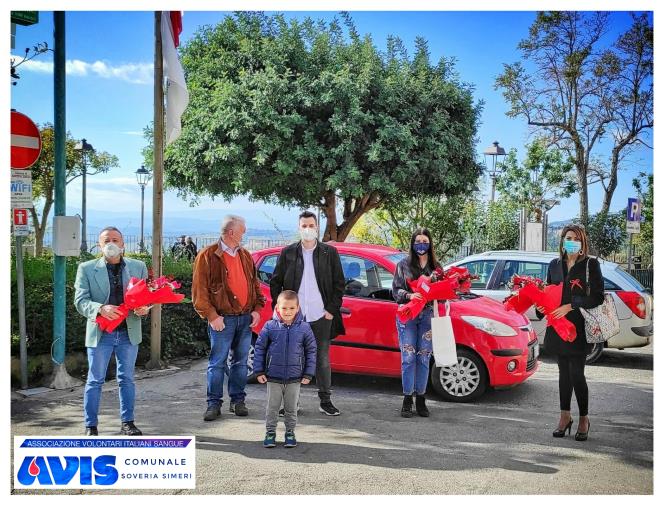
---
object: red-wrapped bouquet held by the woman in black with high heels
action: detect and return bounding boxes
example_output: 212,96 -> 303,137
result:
503,274 -> 576,342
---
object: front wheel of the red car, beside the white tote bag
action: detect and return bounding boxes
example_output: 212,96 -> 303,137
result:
430,348 -> 489,402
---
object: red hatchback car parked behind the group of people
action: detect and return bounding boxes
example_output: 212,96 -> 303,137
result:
249,243 -> 539,402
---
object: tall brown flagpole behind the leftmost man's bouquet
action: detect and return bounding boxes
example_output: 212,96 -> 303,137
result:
145,11 -> 164,369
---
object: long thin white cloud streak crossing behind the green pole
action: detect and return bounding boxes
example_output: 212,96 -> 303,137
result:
12,56 -> 153,84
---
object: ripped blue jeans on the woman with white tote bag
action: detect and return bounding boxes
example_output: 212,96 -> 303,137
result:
397,307 -> 433,395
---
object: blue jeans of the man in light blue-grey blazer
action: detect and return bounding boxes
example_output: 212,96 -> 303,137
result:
83,330 -> 138,427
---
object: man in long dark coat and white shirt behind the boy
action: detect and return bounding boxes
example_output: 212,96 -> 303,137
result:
270,211 -> 346,416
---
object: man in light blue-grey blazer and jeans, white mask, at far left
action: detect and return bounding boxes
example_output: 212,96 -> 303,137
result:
74,227 -> 149,436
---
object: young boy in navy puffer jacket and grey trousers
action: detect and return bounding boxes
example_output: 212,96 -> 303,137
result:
254,290 -> 316,448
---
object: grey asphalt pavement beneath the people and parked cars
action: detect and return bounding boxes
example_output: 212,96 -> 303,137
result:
12,347 -> 653,494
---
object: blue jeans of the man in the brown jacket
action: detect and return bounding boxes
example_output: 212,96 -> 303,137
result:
207,314 -> 251,407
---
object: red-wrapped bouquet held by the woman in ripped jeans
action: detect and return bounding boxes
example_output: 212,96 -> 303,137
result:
397,267 -> 478,323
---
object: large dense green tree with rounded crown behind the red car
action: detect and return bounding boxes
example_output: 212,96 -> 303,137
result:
165,13 -> 481,241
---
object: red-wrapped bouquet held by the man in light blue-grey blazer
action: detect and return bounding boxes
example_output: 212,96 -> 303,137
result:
96,276 -> 184,332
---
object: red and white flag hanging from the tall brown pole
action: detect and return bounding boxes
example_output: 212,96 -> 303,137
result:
161,11 -> 189,144
